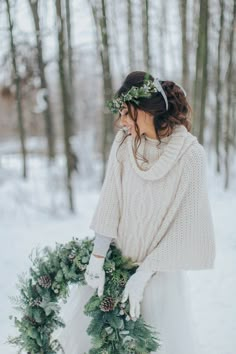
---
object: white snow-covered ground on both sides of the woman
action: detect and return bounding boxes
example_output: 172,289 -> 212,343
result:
0,147 -> 236,354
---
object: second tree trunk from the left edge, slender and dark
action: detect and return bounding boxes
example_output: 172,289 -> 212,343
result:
28,0 -> 55,159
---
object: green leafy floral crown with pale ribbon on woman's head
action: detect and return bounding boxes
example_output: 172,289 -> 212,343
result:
107,78 -> 168,114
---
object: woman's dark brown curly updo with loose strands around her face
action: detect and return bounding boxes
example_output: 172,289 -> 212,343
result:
115,71 -> 192,165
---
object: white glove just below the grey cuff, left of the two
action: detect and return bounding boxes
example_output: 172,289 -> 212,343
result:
84,253 -> 105,297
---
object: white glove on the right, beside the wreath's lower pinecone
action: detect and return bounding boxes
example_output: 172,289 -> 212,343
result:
121,270 -> 154,321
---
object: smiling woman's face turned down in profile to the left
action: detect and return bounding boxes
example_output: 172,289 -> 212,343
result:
120,105 -> 153,137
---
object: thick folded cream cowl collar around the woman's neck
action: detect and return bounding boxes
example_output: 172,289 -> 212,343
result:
127,125 -> 197,181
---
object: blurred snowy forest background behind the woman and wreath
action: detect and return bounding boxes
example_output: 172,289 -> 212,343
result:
0,0 -> 236,354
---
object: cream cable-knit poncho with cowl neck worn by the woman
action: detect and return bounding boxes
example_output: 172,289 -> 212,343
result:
90,125 -> 215,271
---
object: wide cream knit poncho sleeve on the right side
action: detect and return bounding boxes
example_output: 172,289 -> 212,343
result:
138,143 -> 215,271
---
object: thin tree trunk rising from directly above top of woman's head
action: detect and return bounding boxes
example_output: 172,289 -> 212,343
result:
142,0 -> 150,72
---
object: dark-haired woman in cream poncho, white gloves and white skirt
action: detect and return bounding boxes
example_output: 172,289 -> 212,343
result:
54,71 -> 215,354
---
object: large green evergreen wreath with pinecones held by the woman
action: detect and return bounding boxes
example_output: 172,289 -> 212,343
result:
7,237 -> 160,354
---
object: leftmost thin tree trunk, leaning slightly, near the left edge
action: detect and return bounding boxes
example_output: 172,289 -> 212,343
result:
5,0 -> 27,178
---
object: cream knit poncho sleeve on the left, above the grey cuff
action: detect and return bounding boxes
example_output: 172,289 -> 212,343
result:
89,131 -> 123,238
